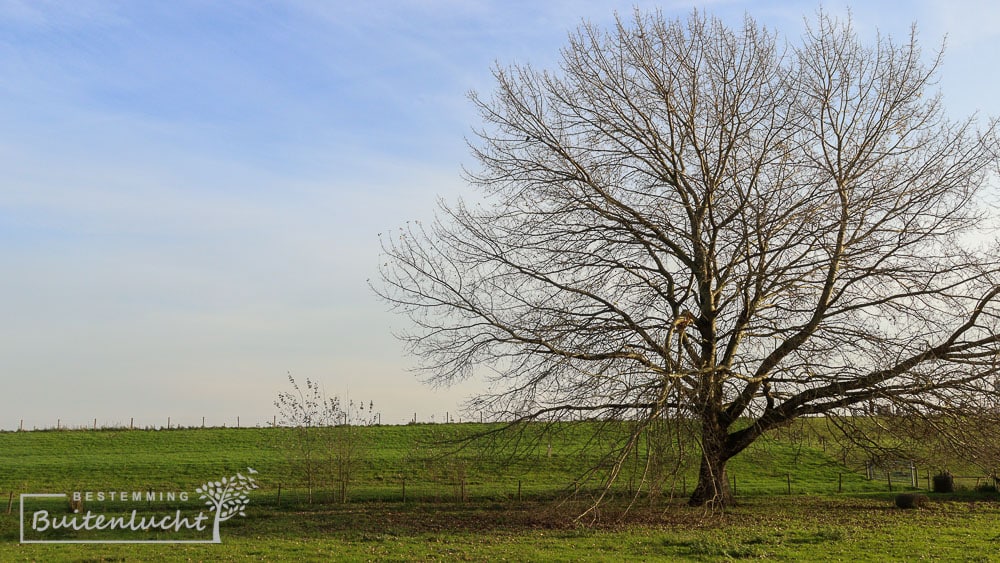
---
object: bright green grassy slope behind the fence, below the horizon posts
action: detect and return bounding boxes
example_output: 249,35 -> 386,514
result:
0,423 -> 884,500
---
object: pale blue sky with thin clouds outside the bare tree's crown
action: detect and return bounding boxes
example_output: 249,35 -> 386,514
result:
0,0 -> 1000,430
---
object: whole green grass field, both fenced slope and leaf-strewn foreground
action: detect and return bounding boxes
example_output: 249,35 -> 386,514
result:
0,424 -> 1000,561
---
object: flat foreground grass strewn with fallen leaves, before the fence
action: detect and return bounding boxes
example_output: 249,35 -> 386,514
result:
7,496 -> 1000,561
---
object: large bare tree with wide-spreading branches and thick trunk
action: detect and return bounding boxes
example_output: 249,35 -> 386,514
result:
378,13 -> 1000,505
